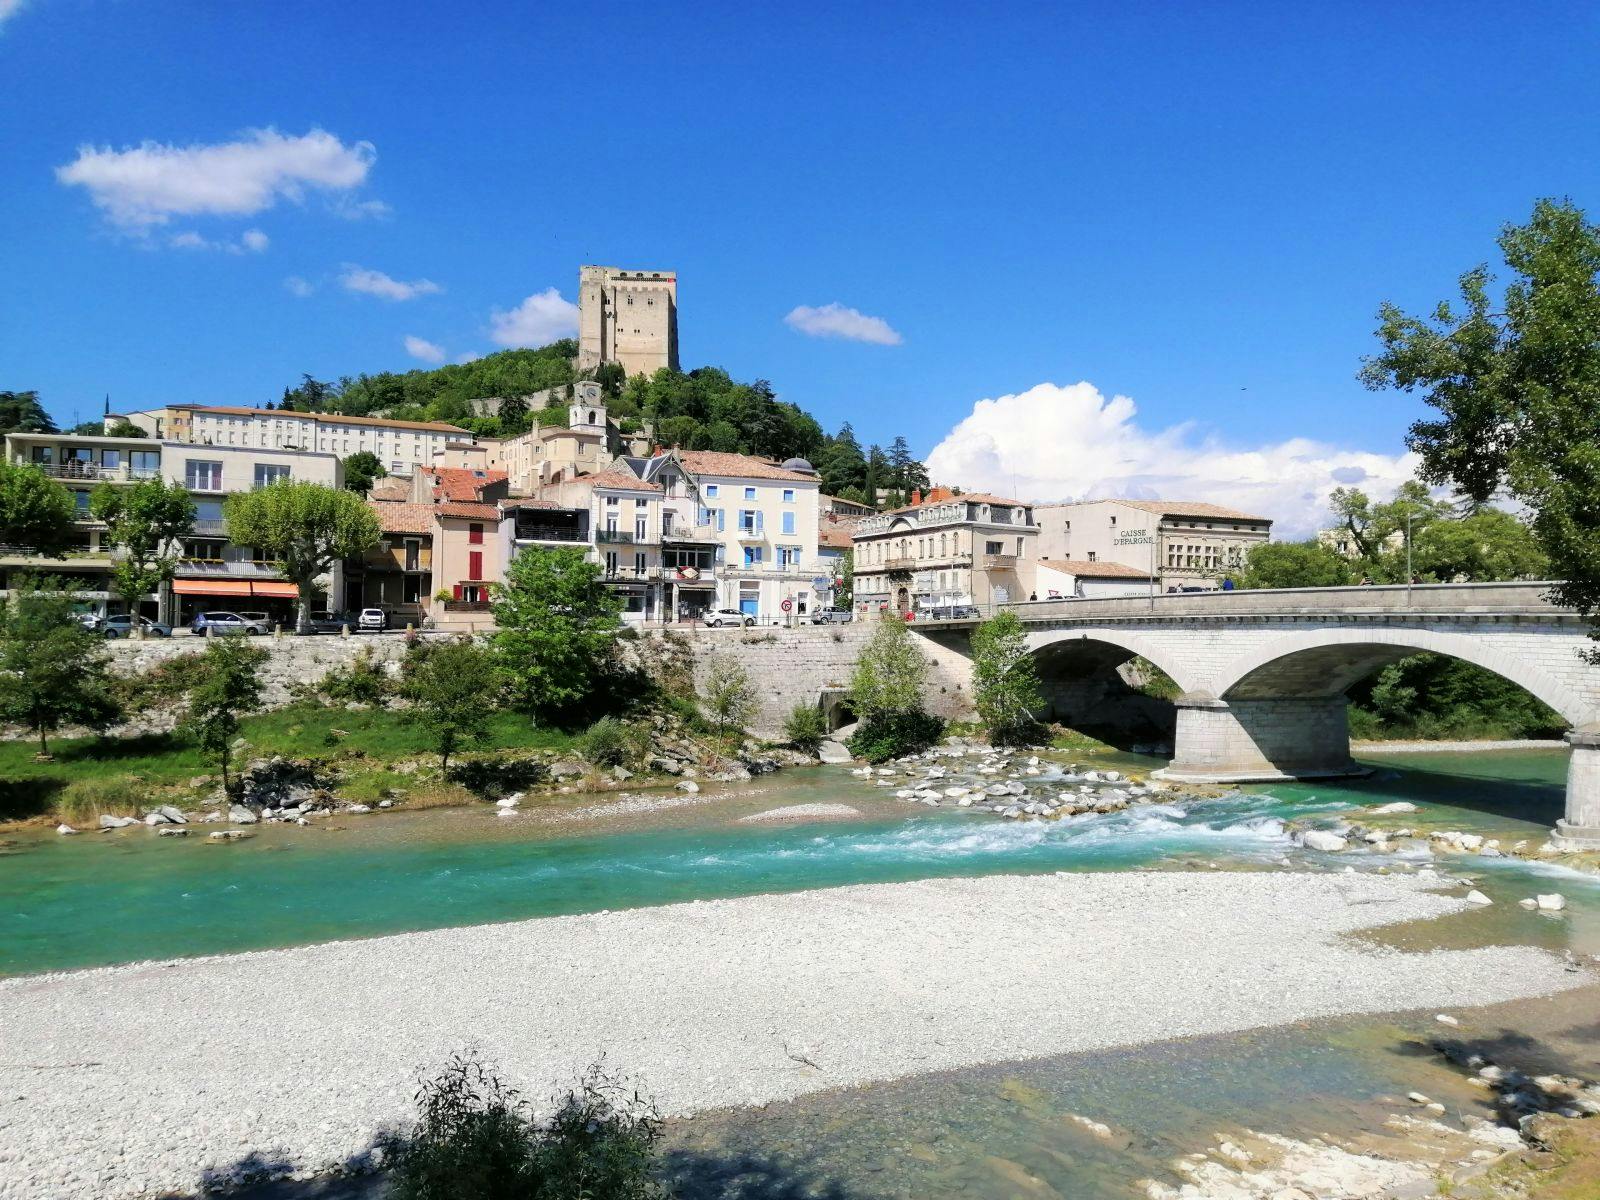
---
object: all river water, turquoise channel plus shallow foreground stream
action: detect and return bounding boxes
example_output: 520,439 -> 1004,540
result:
0,750 -> 1600,1200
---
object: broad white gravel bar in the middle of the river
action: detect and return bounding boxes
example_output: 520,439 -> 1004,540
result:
0,872 -> 1590,1200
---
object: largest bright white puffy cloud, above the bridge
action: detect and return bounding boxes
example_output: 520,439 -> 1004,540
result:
928,382 -> 1418,538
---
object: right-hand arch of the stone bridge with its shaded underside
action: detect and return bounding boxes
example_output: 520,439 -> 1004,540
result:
1214,626 -> 1597,726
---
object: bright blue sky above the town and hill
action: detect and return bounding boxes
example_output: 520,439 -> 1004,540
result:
0,0 -> 1600,531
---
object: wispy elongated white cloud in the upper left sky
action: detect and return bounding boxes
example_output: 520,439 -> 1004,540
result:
54,127 -> 376,232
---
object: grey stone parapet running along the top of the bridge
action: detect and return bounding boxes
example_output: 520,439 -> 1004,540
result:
908,579 -> 1573,624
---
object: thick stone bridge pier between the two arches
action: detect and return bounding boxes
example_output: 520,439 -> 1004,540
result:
1157,696 -> 1363,784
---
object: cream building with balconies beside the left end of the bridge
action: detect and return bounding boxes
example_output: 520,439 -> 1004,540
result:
853,488 -> 1038,613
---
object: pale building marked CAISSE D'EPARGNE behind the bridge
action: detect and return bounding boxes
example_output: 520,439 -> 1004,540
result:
1035,499 -> 1272,592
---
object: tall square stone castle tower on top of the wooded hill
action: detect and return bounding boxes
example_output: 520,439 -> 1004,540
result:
578,266 -> 678,376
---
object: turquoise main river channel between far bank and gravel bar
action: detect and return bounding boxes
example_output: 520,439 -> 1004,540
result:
0,750 -> 1600,974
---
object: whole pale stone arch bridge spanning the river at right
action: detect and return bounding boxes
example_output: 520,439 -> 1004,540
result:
918,582 -> 1600,850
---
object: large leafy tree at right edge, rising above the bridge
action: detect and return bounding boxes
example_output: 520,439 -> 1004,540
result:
1362,200 -> 1600,637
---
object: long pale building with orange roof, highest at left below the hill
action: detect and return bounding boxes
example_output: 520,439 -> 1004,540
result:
107,405 -> 474,475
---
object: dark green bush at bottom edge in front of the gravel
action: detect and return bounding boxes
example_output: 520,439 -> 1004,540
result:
386,1056 -> 666,1200
